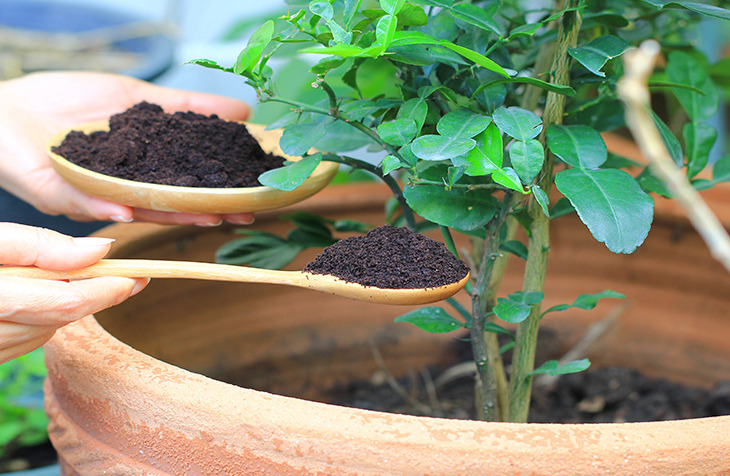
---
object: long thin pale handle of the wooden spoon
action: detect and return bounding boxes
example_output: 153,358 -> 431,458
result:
0,259 -> 305,285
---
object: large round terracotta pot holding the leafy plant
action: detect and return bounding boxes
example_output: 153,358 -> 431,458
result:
46,181 -> 730,475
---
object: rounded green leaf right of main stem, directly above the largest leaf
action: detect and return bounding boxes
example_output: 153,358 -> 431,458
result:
547,125 -> 608,170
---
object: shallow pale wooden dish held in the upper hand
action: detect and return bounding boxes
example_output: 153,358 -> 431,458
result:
48,121 -> 337,214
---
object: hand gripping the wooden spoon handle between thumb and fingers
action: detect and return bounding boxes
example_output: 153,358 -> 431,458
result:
0,223 -> 149,364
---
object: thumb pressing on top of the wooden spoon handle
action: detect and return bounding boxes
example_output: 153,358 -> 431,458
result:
0,223 -> 114,270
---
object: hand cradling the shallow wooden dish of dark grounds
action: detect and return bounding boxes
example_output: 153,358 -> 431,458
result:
0,72 -> 253,226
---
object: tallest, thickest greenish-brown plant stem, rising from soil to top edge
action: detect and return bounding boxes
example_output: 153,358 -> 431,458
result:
509,0 -> 581,422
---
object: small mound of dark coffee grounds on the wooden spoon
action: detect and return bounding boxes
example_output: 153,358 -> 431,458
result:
304,225 -> 469,289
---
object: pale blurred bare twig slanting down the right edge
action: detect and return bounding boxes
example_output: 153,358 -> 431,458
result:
617,41 -> 730,272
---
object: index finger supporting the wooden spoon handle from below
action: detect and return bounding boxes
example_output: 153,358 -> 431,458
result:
0,277 -> 148,327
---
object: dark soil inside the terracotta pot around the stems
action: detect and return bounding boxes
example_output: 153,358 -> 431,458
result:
329,344 -> 730,423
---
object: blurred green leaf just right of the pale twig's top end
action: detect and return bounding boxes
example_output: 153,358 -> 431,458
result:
667,50 -> 720,122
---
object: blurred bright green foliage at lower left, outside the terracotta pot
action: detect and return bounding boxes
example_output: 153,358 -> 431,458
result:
0,350 -> 48,463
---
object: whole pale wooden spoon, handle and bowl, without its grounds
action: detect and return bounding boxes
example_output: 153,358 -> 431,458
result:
0,259 -> 469,305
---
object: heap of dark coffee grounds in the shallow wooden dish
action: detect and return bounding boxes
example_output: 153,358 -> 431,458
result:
53,102 -> 284,188
